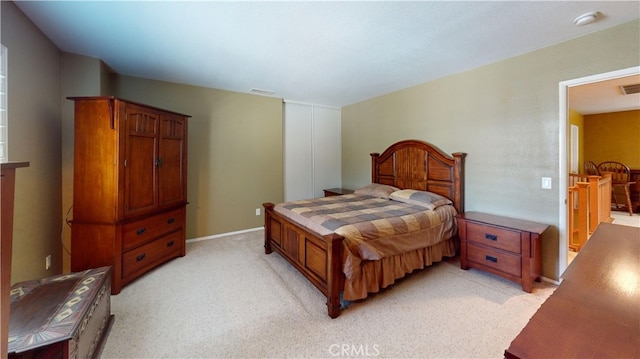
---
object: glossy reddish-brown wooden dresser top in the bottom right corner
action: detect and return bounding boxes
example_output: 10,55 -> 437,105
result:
505,223 -> 640,358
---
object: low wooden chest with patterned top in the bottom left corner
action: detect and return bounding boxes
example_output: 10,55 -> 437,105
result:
9,267 -> 113,358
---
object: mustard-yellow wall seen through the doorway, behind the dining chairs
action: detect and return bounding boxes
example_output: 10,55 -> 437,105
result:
584,111 -> 640,168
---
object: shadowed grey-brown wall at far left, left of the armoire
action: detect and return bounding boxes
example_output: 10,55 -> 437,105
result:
0,1 -> 62,283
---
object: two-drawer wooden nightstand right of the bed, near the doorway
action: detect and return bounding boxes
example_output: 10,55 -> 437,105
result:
457,212 -> 548,293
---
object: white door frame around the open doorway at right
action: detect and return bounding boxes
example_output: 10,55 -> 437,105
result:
558,66 -> 640,281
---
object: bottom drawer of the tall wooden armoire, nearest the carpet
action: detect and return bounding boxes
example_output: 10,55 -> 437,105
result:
122,229 -> 184,283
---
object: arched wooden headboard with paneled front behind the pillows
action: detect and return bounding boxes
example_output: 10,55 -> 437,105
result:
371,140 -> 467,213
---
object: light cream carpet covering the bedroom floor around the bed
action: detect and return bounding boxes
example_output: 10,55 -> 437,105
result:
102,231 -> 555,358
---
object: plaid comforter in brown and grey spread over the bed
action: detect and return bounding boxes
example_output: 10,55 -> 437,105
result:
276,194 -> 457,260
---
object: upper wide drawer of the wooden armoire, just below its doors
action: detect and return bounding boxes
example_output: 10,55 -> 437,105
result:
122,209 -> 184,251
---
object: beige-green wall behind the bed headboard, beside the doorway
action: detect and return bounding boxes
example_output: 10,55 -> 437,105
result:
342,21 -> 640,279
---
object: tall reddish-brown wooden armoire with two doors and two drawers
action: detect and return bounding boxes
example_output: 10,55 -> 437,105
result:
69,97 -> 190,294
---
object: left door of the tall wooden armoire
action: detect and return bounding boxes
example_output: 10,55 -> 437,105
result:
124,104 -> 160,216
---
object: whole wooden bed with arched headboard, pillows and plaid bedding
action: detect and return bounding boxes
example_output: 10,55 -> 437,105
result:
263,140 -> 466,318
